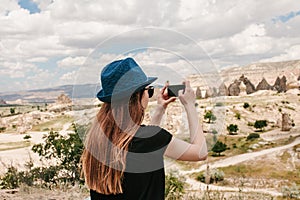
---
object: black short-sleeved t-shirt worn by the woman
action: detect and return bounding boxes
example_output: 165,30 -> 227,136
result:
90,126 -> 172,200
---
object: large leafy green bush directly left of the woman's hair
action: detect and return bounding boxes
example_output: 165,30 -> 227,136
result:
32,125 -> 85,184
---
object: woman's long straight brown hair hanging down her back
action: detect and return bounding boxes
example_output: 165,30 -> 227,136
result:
81,91 -> 144,194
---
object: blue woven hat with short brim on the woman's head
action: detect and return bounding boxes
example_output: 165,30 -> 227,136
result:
97,58 -> 157,103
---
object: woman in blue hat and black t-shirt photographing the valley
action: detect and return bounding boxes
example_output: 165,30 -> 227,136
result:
82,58 -> 207,200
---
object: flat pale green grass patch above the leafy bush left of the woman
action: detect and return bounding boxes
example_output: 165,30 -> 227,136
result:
32,115 -> 74,131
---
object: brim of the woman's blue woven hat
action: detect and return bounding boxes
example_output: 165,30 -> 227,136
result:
97,77 -> 157,103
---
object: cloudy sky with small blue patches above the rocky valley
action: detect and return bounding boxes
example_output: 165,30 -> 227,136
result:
0,0 -> 300,92
